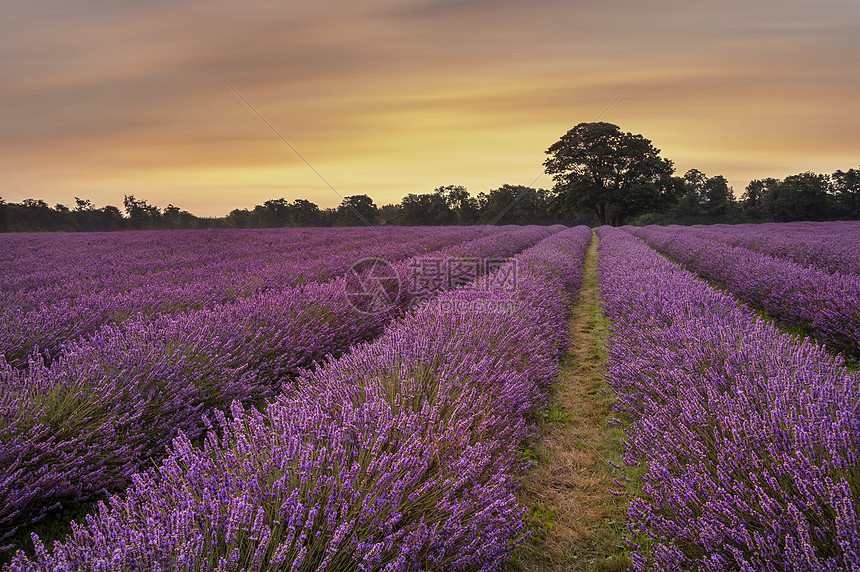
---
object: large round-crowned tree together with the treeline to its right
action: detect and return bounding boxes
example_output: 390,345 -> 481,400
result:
544,122 -> 860,225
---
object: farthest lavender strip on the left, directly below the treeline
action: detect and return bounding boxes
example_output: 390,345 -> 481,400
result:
0,228 -> 386,310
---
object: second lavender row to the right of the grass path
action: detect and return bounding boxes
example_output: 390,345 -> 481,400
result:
628,223 -> 860,358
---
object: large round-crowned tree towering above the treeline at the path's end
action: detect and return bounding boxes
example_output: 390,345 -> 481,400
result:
544,122 -> 683,225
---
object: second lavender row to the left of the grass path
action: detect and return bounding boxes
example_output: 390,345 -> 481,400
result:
0,223 -> 563,541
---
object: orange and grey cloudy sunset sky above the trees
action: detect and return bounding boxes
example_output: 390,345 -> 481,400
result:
0,0 -> 860,216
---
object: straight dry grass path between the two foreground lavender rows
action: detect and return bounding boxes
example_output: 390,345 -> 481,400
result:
509,230 -> 630,572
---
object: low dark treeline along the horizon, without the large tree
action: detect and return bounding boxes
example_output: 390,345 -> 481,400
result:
0,169 -> 860,232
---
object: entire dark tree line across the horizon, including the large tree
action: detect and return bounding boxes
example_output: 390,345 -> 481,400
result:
0,122 -> 860,232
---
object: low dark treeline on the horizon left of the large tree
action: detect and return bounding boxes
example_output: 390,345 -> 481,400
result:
0,185 -> 592,232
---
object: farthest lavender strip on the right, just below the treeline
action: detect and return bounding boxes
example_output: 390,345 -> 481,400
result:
669,221 -> 860,274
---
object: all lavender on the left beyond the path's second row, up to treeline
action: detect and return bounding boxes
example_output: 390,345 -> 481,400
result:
0,227 -> 488,367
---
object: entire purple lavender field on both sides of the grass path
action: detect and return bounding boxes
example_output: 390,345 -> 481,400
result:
0,222 -> 860,571
